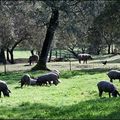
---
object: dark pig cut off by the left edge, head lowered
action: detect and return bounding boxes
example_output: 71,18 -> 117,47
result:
0,80 -> 11,97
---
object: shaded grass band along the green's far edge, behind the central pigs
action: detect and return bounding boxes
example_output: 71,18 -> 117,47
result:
0,68 -> 116,84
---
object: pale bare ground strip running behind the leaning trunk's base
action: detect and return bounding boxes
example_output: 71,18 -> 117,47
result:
0,61 -> 120,72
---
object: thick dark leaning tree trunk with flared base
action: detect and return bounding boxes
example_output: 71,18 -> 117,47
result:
32,9 -> 59,70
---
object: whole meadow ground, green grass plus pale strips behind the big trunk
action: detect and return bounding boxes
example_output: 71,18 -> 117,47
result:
0,50 -> 120,119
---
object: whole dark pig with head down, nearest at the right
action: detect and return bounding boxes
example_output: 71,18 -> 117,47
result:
97,81 -> 120,97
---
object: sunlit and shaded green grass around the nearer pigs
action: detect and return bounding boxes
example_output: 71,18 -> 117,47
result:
0,70 -> 120,119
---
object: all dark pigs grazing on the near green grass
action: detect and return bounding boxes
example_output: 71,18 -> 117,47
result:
0,70 -> 120,97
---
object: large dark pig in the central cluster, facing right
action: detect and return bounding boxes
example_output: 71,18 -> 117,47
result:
36,72 -> 60,85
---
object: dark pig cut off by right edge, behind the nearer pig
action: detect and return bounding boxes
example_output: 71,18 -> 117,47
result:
107,70 -> 120,82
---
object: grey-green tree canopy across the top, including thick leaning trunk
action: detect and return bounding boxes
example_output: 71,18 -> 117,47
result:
0,0 -> 120,70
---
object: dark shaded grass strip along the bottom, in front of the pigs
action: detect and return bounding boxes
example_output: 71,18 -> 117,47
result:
0,98 -> 120,119
